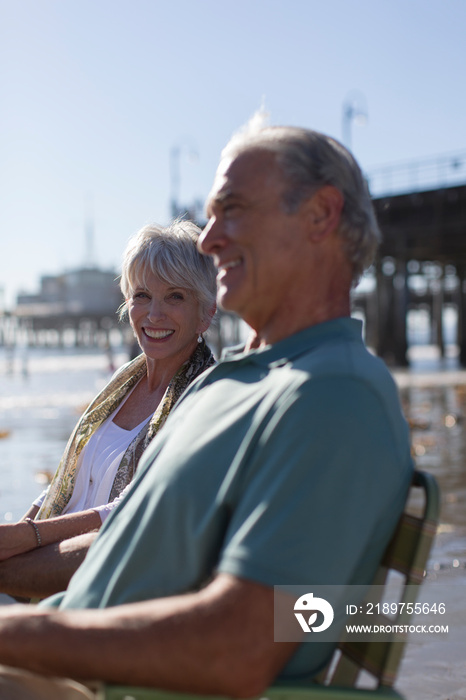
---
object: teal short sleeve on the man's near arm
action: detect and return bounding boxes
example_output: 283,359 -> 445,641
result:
218,378 -> 412,585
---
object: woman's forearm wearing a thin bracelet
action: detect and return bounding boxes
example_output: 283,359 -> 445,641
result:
0,506 -> 102,561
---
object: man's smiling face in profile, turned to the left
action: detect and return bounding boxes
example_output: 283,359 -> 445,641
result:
199,149 -> 310,340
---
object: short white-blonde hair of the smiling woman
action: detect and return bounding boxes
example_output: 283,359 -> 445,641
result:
120,219 -> 216,317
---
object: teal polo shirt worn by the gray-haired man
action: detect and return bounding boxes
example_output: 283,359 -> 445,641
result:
55,318 -> 412,677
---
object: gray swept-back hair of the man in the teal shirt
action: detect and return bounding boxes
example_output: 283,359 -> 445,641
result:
222,114 -> 380,285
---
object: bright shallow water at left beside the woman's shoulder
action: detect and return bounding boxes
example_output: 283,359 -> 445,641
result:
0,348 -> 128,523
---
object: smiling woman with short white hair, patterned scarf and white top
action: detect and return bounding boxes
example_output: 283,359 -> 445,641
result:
0,220 -> 216,560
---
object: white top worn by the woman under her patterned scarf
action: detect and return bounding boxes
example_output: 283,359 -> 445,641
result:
33,404 -> 152,522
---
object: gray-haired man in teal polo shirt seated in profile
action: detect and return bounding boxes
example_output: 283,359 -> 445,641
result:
0,127 -> 412,698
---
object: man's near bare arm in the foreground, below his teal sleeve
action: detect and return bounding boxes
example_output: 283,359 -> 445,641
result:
0,576 -> 295,697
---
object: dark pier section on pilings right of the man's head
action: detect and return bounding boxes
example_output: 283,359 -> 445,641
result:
364,180 -> 466,366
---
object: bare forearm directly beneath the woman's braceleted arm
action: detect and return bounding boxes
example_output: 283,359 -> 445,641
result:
0,533 -> 97,598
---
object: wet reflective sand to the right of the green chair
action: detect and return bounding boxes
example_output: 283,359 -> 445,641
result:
394,356 -> 466,700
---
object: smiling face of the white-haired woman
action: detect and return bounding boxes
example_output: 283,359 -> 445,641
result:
127,275 -> 209,365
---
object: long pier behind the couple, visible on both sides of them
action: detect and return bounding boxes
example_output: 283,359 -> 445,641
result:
0,162 -> 466,366
